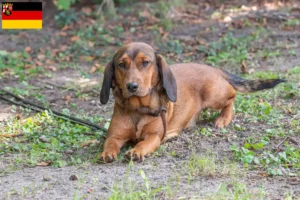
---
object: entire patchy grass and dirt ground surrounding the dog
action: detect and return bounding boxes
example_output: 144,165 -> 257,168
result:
0,0 -> 300,200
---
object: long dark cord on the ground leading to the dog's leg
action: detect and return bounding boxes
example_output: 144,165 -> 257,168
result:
0,89 -> 107,132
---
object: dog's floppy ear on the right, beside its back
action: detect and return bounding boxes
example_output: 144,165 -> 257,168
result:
156,54 -> 177,102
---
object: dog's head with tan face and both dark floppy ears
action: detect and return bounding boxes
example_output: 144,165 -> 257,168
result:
100,42 -> 177,104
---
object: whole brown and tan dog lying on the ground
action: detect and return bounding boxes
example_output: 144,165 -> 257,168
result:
99,42 -> 284,162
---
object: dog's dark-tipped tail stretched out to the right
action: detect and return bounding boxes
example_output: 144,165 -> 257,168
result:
223,71 -> 286,93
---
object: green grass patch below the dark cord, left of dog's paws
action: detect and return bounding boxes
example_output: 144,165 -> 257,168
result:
0,111 -> 103,170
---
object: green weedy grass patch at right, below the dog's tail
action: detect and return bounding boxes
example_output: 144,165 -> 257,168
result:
230,67 -> 300,175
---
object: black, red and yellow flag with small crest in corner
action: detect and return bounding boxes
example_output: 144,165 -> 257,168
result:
2,2 -> 43,29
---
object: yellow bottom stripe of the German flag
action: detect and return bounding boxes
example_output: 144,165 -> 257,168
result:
2,20 -> 43,29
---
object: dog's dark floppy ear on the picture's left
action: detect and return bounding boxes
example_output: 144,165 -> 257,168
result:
100,60 -> 115,104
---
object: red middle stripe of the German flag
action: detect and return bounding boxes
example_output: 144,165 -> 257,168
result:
2,10 -> 43,20
